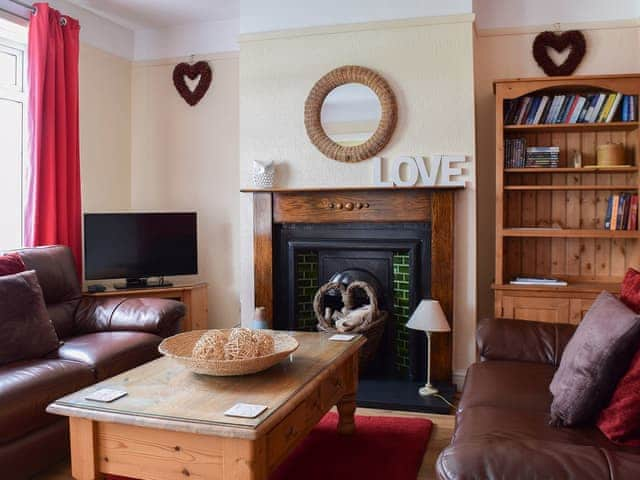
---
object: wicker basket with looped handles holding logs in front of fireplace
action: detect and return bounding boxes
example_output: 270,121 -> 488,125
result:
313,281 -> 389,370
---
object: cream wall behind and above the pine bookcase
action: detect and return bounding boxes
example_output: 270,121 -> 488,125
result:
475,22 -> 640,318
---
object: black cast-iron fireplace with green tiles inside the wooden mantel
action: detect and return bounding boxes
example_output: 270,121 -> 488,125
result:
274,222 -> 431,379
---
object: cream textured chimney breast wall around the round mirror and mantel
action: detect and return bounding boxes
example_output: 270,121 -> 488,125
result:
239,16 -> 476,378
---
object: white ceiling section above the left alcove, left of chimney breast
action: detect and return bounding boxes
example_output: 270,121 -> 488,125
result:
67,0 -> 240,30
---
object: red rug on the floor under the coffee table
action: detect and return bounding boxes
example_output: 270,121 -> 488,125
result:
107,412 -> 433,480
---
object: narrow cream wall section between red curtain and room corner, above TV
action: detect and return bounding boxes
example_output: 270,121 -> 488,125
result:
79,43 -> 131,212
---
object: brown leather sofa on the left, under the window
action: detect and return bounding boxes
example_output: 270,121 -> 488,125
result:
0,246 -> 185,480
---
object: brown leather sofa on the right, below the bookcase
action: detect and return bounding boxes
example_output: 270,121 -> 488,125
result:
436,320 -> 640,480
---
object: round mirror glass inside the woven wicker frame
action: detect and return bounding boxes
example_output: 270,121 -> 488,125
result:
320,83 -> 382,147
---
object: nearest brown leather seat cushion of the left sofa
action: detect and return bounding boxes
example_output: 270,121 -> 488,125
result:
0,359 -> 95,444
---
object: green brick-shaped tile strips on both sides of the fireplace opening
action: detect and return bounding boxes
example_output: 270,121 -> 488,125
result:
295,250 -> 410,375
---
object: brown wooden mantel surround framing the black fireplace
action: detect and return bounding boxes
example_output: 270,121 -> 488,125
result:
241,187 -> 462,380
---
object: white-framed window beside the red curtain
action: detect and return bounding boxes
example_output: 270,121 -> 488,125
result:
0,19 -> 27,250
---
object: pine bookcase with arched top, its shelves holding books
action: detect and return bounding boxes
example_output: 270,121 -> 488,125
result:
493,74 -> 640,323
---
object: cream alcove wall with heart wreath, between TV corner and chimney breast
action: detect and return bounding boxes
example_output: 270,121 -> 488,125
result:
131,53 -> 241,328
